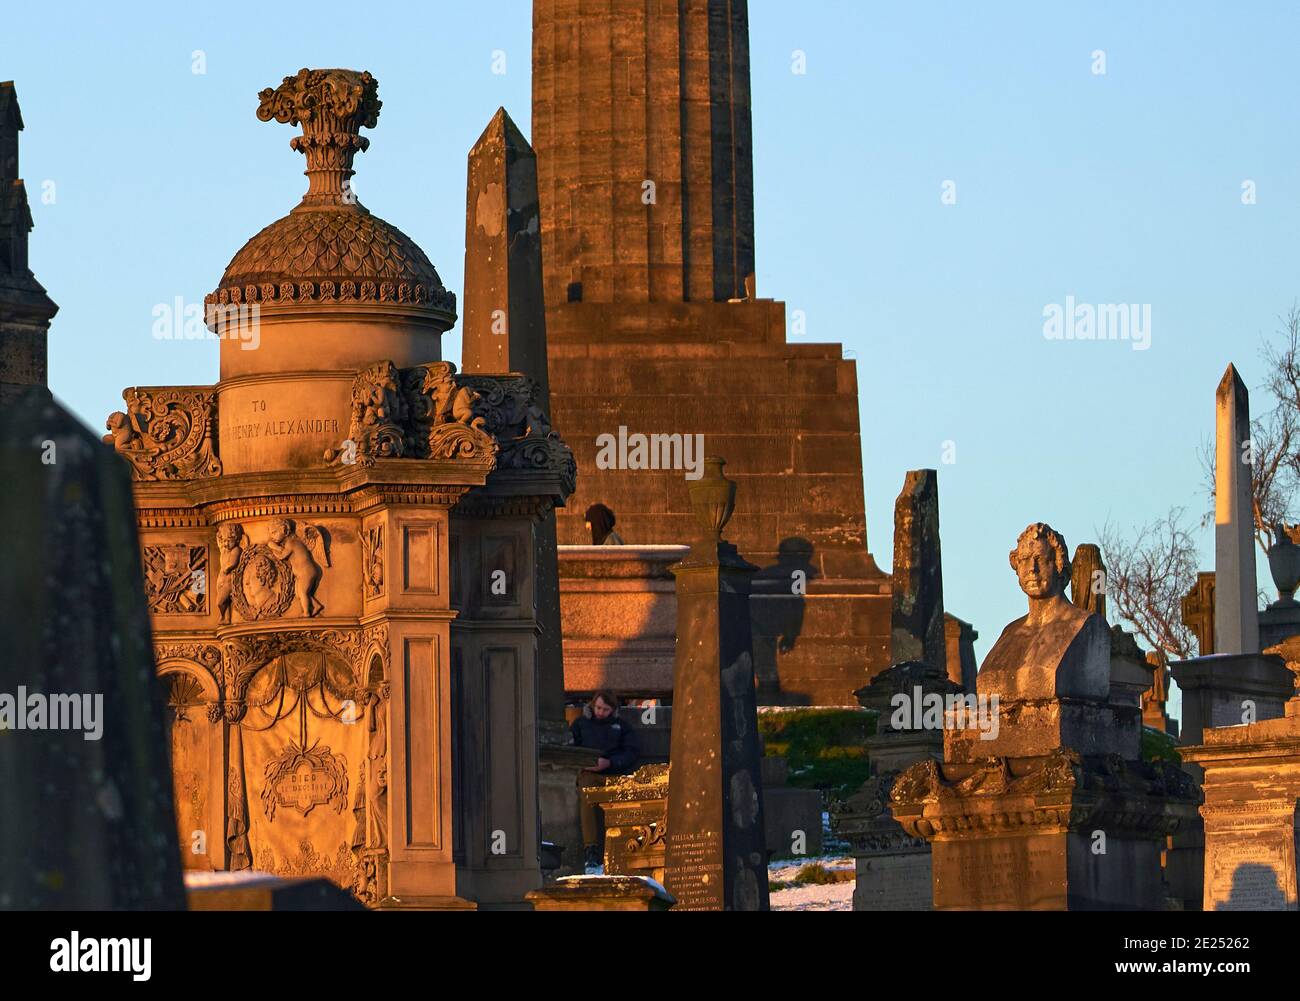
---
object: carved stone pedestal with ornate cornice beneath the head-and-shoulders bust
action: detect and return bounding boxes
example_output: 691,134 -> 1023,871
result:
892,749 -> 1195,910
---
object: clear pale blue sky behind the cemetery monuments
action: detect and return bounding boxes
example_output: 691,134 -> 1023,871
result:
0,0 -> 1300,686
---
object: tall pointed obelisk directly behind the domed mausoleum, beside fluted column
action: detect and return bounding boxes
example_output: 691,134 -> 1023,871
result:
462,108 -> 567,744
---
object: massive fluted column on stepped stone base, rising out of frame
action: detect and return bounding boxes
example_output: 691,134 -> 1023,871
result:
532,0 -> 891,705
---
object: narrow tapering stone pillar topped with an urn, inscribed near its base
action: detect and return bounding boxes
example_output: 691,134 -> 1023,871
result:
664,458 -> 768,910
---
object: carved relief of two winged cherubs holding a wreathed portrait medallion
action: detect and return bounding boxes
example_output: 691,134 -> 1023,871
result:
216,517 -> 330,624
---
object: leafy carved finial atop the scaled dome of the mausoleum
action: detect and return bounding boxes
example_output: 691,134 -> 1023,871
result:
257,68 -> 381,208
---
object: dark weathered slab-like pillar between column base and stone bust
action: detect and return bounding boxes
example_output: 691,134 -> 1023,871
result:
891,469 -> 948,672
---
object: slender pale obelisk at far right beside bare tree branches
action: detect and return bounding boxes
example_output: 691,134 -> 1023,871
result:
1214,365 -> 1260,654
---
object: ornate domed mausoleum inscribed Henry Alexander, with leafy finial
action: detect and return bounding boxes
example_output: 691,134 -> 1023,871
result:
107,69 -> 575,907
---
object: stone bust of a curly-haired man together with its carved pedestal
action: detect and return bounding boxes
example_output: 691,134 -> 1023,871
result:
891,523 -> 1196,910
